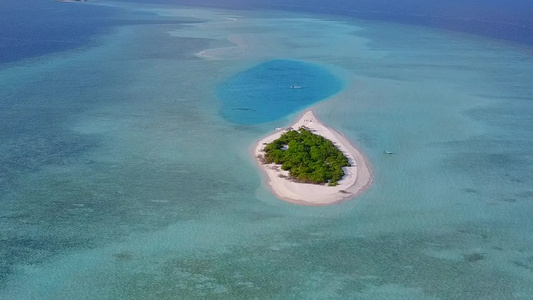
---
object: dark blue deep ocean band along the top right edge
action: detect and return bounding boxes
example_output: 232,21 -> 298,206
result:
121,0 -> 533,45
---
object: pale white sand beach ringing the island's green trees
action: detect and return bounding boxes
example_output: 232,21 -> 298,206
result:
253,110 -> 372,206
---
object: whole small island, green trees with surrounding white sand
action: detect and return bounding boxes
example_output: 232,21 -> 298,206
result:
254,110 -> 372,206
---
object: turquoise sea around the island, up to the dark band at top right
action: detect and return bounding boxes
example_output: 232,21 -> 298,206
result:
0,1 -> 533,300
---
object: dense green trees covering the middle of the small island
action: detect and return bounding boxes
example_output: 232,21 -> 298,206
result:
264,127 -> 350,186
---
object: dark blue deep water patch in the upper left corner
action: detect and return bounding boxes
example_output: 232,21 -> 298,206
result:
0,0 -> 195,67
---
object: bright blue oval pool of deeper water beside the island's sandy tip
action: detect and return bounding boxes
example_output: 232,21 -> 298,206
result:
218,59 -> 342,124
